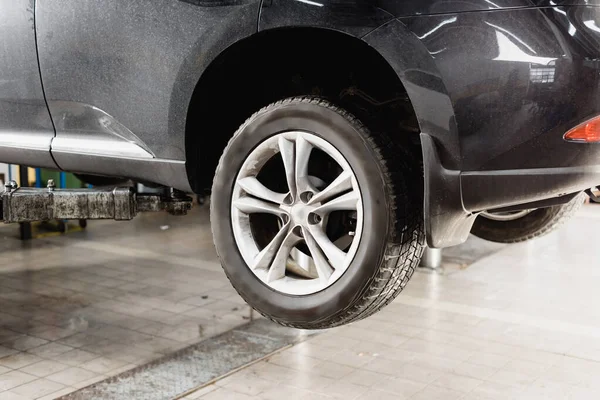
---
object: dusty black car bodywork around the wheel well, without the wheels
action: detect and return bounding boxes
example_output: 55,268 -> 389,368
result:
0,0 -> 600,247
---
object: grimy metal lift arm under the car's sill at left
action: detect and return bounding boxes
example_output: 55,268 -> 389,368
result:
0,180 -> 192,223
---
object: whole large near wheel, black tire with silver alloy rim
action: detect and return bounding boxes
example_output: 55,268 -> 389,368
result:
211,97 -> 423,329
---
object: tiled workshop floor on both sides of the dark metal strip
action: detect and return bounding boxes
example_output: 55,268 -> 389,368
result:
0,206 -> 600,400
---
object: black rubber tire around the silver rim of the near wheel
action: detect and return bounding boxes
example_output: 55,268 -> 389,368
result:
211,97 -> 424,329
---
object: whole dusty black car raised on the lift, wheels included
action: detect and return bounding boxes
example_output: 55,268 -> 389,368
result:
0,0 -> 600,328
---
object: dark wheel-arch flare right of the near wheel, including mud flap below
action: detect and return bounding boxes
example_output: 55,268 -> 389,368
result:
363,20 -> 476,248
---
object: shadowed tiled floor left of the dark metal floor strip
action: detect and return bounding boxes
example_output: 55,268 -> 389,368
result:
0,208 -> 253,400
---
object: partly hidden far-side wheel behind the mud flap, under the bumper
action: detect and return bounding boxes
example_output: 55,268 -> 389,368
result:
471,193 -> 586,243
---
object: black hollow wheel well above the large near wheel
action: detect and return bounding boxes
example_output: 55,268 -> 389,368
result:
185,26 -> 420,192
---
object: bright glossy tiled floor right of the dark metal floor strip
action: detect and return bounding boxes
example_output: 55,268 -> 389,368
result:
187,206 -> 600,400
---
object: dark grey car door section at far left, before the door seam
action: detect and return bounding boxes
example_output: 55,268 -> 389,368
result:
0,0 -> 56,167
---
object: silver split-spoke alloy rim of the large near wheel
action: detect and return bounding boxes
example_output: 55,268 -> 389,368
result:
231,131 -> 363,295
